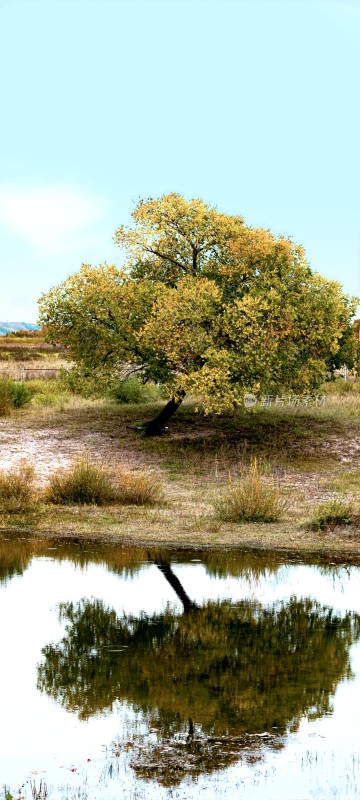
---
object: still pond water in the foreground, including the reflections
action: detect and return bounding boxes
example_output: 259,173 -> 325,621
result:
0,541 -> 360,800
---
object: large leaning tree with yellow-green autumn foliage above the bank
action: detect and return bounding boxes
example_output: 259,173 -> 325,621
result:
40,194 -> 355,433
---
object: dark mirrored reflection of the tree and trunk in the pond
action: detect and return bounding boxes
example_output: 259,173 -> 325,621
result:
38,560 -> 360,785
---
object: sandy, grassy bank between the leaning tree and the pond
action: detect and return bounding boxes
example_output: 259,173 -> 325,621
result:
0,392 -> 360,563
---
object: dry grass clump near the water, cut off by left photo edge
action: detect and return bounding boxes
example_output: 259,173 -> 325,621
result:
0,460 -> 36,514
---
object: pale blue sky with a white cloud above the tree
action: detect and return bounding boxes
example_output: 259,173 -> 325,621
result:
0,0 -> 360,322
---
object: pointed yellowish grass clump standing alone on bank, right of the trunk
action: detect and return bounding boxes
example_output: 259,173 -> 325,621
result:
215,458 -> 288,522
